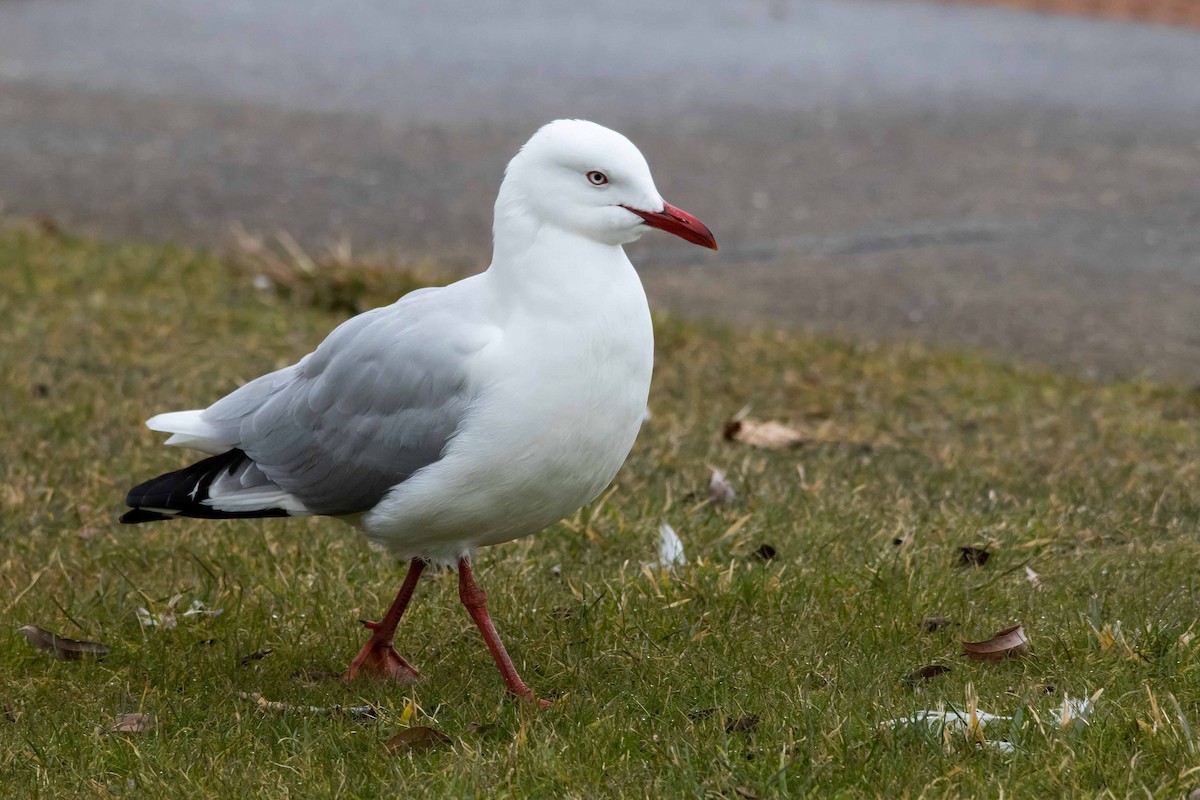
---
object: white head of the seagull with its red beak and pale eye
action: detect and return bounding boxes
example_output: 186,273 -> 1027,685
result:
496,120 -> 716,249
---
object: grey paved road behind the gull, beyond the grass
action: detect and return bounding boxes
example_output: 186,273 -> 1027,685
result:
0,0 -> 1200,381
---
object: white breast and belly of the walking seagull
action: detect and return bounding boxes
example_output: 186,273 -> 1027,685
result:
361,293 -> 654,561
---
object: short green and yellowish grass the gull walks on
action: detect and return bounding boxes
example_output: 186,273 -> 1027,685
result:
0,220 -> 1200,798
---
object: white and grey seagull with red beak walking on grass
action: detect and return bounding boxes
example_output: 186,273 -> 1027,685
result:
121,120 -> 716,706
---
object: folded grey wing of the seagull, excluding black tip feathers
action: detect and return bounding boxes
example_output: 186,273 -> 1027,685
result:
202,282 -> 494,515
